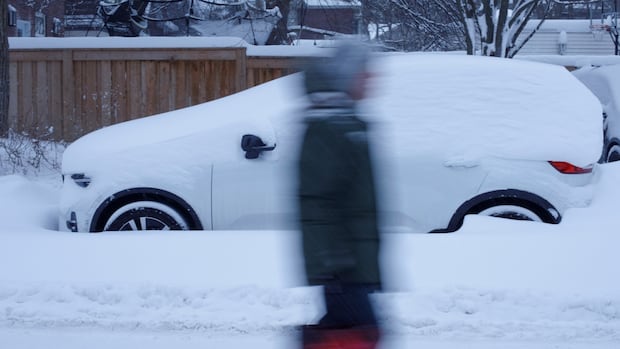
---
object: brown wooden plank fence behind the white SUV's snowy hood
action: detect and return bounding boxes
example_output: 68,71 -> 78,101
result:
9,47 -> 297,141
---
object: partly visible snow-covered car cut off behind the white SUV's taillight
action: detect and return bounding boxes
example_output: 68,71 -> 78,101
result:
573,64 -> 620,162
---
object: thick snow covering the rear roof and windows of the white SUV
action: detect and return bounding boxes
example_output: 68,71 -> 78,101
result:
368,54 -> 602,165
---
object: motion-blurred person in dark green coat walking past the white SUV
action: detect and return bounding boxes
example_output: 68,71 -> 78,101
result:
298,42 -> 381,349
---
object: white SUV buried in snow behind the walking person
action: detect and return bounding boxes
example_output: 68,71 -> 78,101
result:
60,54 -> 602,232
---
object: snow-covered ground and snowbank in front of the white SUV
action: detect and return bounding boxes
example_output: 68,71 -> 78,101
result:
0,154 -> 620,349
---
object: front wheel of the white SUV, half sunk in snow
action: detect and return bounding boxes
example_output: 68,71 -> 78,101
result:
104,201 -> 189,231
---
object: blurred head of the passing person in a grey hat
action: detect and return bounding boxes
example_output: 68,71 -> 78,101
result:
304,41 -> 370,100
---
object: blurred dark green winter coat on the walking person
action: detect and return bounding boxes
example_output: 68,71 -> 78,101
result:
298,102 -> 381,286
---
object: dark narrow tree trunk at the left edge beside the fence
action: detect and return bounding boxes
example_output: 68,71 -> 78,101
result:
0,1 -> 9,136
